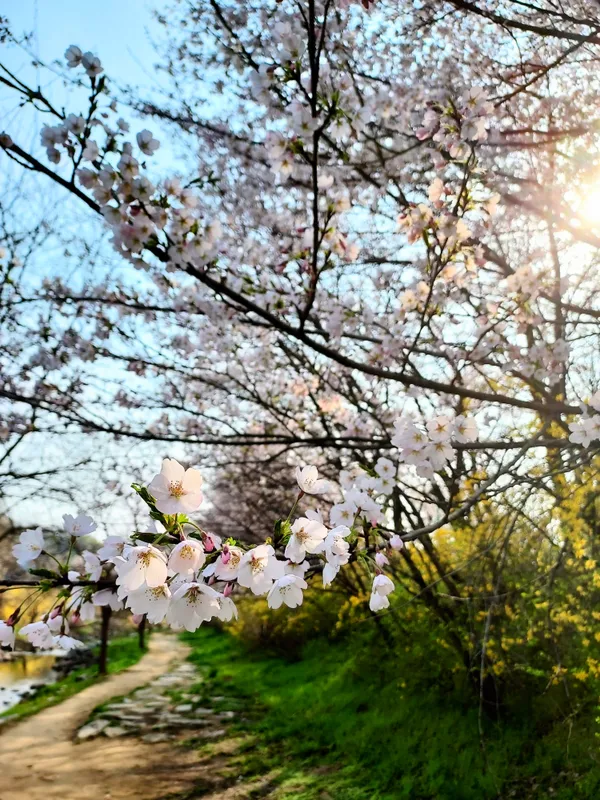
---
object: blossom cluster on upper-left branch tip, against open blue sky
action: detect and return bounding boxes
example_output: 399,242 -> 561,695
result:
34,45 -> 221,269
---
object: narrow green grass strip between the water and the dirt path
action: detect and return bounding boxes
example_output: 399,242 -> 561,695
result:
0,634 -> 143,721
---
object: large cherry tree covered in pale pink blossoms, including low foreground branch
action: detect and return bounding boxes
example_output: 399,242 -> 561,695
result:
0,0 -> 600,680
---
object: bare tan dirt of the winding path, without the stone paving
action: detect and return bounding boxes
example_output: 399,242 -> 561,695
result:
0,633 -> 213,800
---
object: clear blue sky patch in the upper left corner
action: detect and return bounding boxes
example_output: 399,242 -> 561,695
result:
0,0 -> 189,180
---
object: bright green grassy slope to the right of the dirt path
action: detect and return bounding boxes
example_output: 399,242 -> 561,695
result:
184,629 -> 600,800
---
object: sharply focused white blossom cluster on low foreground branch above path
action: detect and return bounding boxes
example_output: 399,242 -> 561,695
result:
0,458 -> 402,649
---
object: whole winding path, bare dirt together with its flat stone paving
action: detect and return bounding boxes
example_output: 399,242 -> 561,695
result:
0,633 -> 276,800
